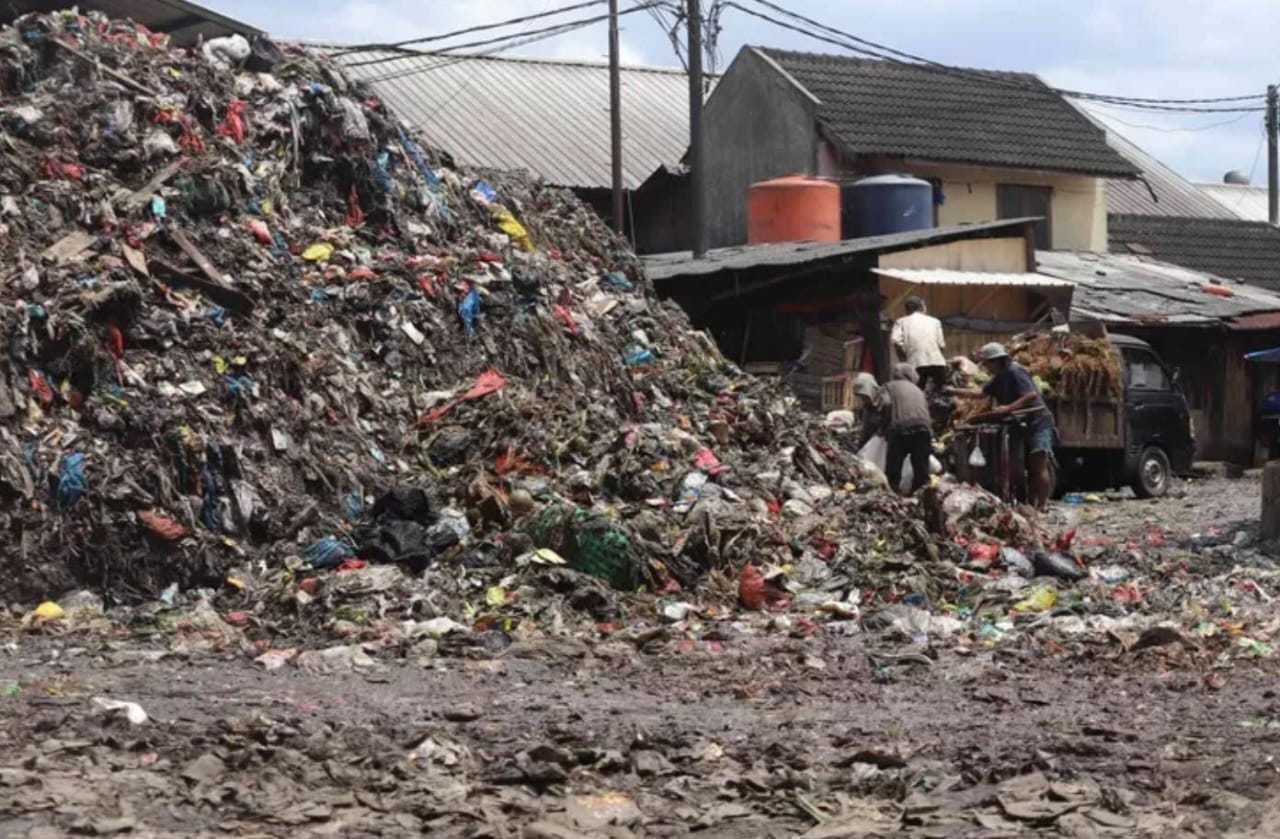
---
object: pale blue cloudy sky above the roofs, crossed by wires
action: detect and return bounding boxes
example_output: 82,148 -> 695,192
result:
204,0 -> 1280,184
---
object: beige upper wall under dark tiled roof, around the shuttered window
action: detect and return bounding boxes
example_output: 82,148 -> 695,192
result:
909,164 -> 1107,252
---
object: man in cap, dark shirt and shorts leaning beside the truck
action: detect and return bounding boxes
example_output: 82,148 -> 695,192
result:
948,343 -> 1057,510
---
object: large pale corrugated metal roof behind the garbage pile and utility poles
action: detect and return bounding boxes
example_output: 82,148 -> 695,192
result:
335,51 -> 689,190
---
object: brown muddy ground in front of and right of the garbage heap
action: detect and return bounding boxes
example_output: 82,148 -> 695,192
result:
0,478 -> 1280,839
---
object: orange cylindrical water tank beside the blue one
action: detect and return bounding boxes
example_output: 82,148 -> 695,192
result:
746,174 -> 840,245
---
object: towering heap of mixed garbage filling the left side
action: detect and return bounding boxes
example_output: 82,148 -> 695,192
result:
0,6 -> 906,602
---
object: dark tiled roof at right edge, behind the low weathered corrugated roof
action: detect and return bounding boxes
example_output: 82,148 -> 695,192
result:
1107,215 -> 1280,291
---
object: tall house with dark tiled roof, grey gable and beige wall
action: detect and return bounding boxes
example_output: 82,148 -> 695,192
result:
704,47 -> 1137,251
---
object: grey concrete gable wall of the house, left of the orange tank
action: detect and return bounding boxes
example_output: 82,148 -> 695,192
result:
703,49 -> 818,247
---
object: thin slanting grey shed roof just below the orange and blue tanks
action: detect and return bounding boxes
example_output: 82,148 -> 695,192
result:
640,218 -> 1039,281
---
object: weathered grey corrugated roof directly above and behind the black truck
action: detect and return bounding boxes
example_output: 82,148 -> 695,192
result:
1036,251 -> 1280,325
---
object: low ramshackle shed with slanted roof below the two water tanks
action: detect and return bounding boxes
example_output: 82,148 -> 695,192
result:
644,218 -> 1054,409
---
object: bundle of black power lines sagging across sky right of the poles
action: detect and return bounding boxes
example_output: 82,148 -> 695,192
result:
724,0 -> 1263,113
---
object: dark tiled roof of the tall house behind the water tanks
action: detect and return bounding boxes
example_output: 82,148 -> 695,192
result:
759,49 -> 1135,177
